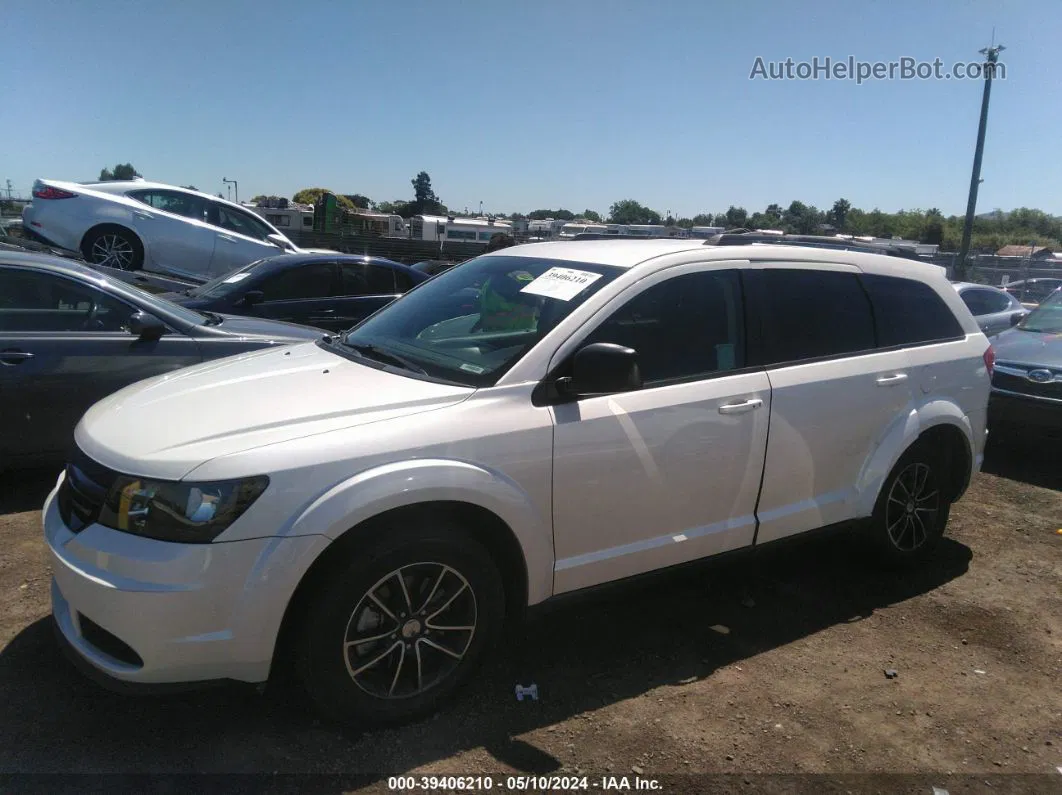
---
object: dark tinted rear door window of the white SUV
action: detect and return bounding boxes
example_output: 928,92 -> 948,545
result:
764,269 -> 875,364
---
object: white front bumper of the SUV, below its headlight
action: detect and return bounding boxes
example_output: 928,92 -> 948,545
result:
44,476 -> 328,685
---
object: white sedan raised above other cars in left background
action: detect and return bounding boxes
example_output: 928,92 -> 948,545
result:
22,179 -> 298,279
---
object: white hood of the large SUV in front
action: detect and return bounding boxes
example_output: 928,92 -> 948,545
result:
74,343 -> 474,480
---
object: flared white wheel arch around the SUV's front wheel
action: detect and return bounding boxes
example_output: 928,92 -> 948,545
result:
290,459 -> 553,605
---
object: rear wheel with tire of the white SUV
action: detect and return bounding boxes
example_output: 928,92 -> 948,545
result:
870,443 -> 953,565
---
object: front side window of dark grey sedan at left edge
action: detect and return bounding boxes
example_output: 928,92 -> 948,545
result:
0,269 -> 136,332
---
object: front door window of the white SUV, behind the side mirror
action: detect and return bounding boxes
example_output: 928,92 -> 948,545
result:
584,271 -> 746,384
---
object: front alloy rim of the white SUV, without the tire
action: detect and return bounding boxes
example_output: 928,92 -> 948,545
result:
343,563 -> 478,698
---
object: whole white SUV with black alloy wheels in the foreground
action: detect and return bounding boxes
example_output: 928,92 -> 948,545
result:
44,240 -> 992,723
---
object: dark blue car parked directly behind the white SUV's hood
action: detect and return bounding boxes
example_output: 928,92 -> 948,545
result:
162,254 -> 428,331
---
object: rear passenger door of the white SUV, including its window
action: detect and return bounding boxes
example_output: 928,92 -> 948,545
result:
756,263 -> 912,542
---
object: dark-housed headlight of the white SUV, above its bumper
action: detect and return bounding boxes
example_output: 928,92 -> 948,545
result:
99,476 -> 269,543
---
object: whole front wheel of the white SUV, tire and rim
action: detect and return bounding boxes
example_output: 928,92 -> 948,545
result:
297,522 -> 504,726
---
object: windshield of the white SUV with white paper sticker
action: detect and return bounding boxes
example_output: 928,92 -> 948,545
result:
335,255 -> 622,386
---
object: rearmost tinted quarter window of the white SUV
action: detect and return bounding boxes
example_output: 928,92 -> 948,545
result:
861,274 -> 963,348
